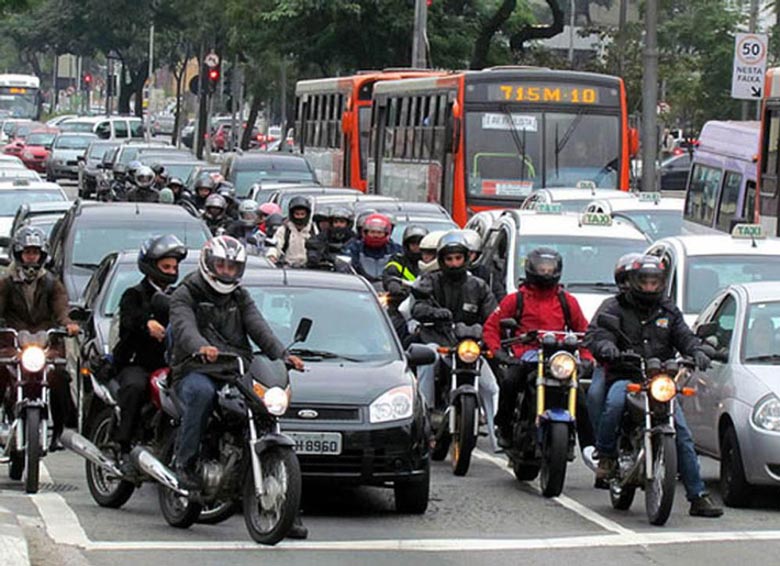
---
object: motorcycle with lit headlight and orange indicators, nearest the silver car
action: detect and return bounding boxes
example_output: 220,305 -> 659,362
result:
598,314 -> 695,525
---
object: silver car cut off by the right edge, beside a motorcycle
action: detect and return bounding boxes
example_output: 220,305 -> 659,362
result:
682,281 -> 780,507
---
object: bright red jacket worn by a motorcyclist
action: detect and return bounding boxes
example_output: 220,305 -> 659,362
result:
483,285 -> 593,360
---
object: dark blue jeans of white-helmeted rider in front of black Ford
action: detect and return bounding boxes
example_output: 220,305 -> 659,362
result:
176,372 -> 217,467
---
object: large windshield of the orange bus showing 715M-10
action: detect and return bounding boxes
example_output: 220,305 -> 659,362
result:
466,110 -> 620,200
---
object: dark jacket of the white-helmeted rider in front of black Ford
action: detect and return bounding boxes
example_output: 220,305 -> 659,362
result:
170,272 -> 285,379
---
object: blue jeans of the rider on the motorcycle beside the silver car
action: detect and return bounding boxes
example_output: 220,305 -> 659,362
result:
596,380 -> 706,501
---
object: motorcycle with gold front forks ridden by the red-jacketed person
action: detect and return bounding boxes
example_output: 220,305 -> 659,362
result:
501,319 -> 583,497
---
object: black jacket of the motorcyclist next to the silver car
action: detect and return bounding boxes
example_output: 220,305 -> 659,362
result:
585,293 -> 701,382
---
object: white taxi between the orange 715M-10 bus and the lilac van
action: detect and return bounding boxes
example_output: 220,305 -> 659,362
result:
585,191 -> 686,241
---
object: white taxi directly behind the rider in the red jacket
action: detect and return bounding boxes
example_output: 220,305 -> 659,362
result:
472,203 -> 649,320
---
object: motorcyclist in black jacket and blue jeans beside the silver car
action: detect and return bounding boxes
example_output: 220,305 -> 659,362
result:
586,255 -> 723,517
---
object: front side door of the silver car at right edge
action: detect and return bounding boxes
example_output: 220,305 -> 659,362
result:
683,291 -> 739,454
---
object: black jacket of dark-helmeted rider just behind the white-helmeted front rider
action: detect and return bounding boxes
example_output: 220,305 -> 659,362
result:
114,277 -> 168,372
